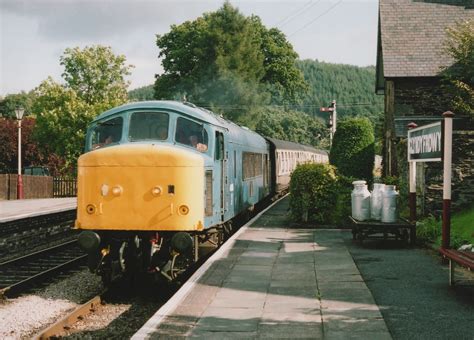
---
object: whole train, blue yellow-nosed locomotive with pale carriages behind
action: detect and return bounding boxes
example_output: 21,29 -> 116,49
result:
76,101 -> 328,281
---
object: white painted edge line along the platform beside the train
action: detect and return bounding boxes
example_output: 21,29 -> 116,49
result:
131,195 -> 287,340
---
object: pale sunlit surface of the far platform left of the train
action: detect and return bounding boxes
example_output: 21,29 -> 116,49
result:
0,197 -> 77,223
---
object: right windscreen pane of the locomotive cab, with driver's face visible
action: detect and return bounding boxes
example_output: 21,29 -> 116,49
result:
175,117 -> 209,152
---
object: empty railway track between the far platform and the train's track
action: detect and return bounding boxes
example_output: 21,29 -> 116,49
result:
0,240 -> 87,297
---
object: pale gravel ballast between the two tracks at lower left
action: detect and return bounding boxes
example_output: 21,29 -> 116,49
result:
0,269 -> 102,339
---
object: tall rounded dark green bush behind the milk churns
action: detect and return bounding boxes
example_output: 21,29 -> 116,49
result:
329,118 -> 375,185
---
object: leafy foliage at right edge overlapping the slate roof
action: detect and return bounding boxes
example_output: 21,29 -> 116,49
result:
442,20 -> 474,118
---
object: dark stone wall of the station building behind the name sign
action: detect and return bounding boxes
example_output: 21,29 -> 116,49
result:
392,78 -> 474,215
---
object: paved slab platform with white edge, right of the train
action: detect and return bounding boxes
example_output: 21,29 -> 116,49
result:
132,198 -> 391,339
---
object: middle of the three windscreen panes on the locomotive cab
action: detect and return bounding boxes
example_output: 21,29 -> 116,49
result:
129,112 -> 170,142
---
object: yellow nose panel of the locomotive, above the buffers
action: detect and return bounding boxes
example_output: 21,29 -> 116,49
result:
76,144 -> 204,230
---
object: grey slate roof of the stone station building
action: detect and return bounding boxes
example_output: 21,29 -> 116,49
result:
377,0 -> 474,81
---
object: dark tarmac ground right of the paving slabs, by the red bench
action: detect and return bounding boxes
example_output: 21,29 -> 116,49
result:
346,233 -> 474,340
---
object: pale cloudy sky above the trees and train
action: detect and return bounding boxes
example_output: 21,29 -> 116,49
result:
0,0 -> 378,96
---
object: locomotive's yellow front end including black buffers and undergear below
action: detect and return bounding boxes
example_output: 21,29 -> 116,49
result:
76,143 -> 204,284
